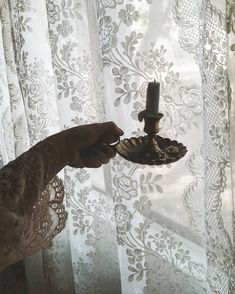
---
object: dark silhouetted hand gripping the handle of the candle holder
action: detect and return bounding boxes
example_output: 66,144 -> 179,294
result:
47,122 -> 124,168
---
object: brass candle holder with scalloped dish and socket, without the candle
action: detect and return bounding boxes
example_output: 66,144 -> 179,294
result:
115,109 -> 187,165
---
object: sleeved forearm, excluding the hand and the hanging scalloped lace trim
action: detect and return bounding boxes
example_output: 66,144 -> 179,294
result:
0,141 -> 59,270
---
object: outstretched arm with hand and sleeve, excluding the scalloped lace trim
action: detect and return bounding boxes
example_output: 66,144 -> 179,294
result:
0,122 -> 123,270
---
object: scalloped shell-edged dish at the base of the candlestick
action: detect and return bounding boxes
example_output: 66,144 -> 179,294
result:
115,135 -> 187,165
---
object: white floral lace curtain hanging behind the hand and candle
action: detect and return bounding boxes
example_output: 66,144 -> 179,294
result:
0,0 -> 235,294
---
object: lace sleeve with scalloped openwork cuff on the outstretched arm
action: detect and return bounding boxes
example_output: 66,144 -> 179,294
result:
0,141 -> 67,269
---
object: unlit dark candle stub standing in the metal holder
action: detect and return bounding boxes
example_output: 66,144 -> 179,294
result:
146,80 -> 160,114
